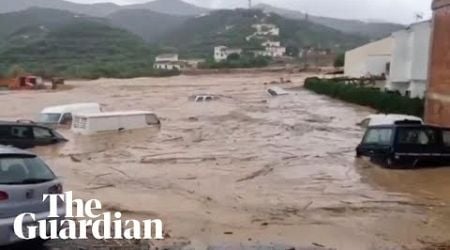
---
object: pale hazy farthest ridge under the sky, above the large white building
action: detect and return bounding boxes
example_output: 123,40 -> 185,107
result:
255,4 -> 404,39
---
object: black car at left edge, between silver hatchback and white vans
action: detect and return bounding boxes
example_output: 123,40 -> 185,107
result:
0,121 -> 67,149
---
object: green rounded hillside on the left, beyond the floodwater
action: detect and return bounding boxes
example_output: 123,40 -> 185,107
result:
0,20 -> 158,78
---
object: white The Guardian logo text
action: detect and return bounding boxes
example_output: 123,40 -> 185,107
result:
14,192 -> 164,240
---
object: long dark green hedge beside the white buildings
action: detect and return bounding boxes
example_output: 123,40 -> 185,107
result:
305,78 -> 424,117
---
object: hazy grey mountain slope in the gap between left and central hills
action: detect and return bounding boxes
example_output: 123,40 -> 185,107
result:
107,9 -> 188,43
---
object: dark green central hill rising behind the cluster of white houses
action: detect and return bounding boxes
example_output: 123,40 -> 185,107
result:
162,9 -> 366,57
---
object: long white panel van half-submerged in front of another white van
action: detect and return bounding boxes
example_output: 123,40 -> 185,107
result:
72,111 -> 161,135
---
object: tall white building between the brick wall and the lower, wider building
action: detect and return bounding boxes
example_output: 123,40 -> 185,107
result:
386,21 -> 432,98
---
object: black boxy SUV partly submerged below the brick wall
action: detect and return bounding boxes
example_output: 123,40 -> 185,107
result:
356,122 -> 450,168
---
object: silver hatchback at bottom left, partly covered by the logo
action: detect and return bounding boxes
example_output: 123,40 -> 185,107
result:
0,146 -> 65,246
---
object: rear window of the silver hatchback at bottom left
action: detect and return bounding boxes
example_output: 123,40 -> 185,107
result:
0,156 -> 55,185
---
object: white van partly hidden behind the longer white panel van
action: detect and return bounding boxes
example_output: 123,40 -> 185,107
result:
39,103 -> 102,126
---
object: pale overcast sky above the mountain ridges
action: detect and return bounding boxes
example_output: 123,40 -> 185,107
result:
70,0 -> 432,23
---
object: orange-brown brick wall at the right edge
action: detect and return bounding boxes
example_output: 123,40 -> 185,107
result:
425,0 -> 450,127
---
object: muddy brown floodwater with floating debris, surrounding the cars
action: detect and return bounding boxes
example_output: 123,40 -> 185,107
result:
0,73 -> 450,249
